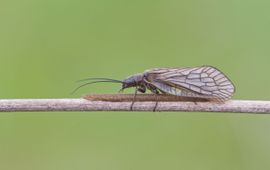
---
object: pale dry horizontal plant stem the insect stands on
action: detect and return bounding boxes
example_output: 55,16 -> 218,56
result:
0,94 -> 270,113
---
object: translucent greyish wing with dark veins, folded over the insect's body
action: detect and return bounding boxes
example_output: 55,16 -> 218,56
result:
144,66 -> 235,101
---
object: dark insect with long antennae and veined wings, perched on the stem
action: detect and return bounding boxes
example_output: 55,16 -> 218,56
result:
74,66 -> 235,110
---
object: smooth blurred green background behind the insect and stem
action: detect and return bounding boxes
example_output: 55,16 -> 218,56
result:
0,0 -> 270,170
